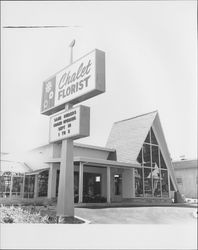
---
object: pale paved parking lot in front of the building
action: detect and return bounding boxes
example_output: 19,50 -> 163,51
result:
75,207 -> 197,224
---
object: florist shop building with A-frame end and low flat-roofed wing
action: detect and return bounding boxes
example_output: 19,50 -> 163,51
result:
0,111 -> 178,203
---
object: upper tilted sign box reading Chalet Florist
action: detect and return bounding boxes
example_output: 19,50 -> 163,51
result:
41,49 -> 105,115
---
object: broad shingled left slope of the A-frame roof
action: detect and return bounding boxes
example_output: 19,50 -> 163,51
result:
106,111 -> 157,163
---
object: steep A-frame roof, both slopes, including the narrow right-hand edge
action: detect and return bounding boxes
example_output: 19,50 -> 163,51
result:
106,111 -> 178,190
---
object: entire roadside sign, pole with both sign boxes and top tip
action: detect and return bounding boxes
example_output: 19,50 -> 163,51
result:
41,40 -> 105,222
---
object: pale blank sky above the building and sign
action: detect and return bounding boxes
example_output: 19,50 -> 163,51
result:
1,1 -> 197,159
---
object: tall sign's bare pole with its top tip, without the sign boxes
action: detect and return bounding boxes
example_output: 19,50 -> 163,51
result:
57,40 -> 75,220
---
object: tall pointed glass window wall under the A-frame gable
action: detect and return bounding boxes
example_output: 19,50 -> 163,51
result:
135,128 -> 169,197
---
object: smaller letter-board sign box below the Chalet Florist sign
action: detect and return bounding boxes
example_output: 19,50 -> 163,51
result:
49,105 -> 90,142
